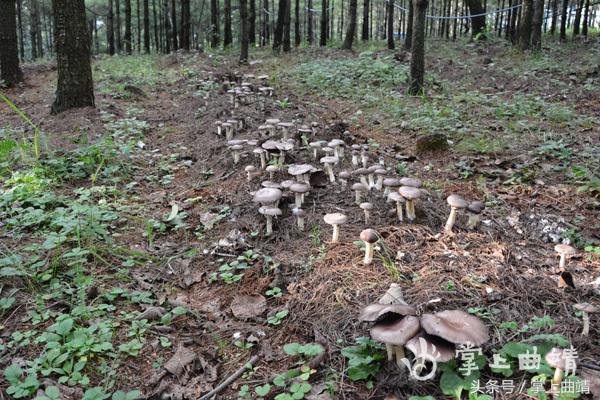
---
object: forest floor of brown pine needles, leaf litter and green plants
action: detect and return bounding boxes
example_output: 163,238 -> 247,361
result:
0,37 -> 600,399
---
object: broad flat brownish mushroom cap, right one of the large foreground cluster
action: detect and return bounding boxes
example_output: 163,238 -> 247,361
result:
421,310 -> 490,346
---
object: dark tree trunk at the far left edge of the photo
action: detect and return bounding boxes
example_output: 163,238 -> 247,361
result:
0,0 -> 23,87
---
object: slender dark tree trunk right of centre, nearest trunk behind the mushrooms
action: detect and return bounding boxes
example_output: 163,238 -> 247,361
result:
408,0 -> 427,95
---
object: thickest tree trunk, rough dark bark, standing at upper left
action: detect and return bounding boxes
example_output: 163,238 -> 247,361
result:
52,0 -> 94,114
